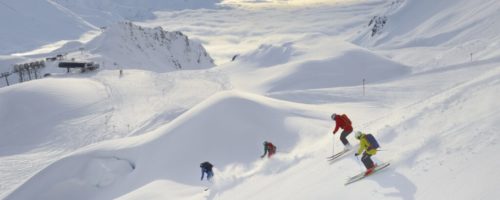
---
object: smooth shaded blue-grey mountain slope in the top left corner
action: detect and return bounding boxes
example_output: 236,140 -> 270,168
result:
0,0 -> 97,55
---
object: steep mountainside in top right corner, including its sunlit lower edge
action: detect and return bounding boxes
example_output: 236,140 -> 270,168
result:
352,0 -> 500,68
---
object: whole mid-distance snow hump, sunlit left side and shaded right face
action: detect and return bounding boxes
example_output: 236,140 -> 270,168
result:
227,38 -> 410,92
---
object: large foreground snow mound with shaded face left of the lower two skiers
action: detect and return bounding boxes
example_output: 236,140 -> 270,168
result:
7,92 -> 324,199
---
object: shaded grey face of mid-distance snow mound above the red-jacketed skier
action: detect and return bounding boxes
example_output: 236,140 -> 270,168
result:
267,48 -> 410,92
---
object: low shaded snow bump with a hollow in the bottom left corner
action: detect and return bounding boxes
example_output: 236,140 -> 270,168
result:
7,156 -> 135,200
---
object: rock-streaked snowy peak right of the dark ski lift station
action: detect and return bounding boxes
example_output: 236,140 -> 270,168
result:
85,22 -> 214,72
